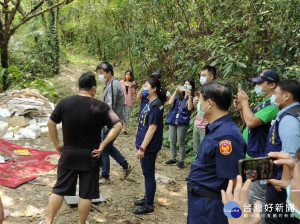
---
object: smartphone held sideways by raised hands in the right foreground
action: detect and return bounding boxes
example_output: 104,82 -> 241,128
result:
239,157 -> 277,182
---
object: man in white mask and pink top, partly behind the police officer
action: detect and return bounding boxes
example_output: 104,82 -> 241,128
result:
193,65 -> 217,153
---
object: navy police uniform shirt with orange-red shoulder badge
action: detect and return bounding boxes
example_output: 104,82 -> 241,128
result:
188,115 -> 246,192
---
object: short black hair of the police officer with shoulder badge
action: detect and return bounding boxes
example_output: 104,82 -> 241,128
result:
201,81 -> 232,111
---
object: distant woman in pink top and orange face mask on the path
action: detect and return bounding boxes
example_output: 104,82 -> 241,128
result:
120,70 -> 136,135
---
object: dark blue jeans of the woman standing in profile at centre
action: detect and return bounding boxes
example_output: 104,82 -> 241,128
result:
141,152 -> 158,206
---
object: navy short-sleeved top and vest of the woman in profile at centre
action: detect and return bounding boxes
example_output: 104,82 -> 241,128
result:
135,98 -> 164,152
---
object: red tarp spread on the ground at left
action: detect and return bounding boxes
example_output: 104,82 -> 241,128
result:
0,139 -> 58,188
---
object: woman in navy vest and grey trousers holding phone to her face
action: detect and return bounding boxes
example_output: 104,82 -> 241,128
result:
165,79 -> 195,169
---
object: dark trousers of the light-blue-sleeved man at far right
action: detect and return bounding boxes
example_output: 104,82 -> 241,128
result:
265,184 -> 300,224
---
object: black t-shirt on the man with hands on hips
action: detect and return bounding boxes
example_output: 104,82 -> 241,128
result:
50,95 -> 120,170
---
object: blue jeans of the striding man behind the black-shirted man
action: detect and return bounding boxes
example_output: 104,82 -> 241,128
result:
101,127 -> 128,178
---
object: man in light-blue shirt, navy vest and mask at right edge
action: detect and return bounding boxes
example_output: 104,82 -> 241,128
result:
265,80 -> 300,223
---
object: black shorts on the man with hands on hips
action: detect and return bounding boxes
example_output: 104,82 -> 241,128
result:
52,166 -> 100,199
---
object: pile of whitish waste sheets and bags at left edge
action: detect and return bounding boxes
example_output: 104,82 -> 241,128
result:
0,89 -> 54,140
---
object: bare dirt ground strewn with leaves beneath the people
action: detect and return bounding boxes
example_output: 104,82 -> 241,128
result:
0,62 -> 189,224
